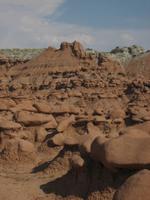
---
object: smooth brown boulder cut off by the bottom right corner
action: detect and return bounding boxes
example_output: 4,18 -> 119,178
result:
113,170 -> 150,200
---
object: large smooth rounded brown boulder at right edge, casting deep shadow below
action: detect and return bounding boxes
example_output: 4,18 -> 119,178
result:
91,133 -> 150,169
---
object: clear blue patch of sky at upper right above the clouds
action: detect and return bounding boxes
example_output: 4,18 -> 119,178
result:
59,0 -> 150,29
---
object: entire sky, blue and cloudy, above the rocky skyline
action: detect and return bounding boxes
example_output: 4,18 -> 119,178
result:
0,0 -> 150,51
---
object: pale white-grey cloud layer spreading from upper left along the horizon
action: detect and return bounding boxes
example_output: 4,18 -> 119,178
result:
0,0 -> 150,50
